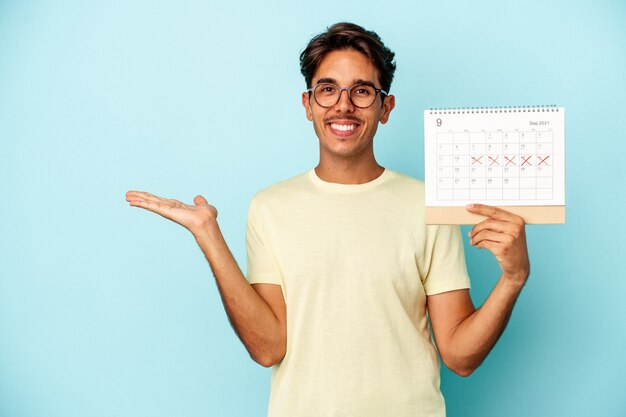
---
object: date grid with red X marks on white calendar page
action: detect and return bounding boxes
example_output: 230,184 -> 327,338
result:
436,130 -> 554,201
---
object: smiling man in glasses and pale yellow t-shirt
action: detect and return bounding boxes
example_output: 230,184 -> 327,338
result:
127,23 -> 529,417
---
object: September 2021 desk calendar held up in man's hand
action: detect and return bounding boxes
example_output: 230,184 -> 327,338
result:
424,106 -> 565,224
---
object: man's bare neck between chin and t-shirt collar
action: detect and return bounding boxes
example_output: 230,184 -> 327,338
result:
315,158 -> 385,184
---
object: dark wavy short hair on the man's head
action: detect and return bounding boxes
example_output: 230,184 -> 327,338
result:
300,22 -> 396,92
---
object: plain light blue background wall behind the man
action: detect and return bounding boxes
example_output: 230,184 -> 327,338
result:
0,0 -> 626,417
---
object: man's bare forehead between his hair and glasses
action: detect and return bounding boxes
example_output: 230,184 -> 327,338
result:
313,49 -> 378,86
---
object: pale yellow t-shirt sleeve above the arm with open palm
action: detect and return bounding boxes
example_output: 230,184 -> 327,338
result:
246,198 -> 282,285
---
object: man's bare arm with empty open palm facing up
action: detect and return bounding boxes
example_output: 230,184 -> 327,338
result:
126,191 -> 287,366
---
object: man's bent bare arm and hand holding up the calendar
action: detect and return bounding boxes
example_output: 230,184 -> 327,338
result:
428,204 -> 530,376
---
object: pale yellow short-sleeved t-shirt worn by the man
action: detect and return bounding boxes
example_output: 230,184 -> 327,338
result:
247,169 -> 469,417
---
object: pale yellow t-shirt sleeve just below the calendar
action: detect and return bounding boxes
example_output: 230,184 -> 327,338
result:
423,225 -> 470,295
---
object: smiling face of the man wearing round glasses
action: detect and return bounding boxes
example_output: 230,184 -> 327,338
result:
302,49 -> 395,161
